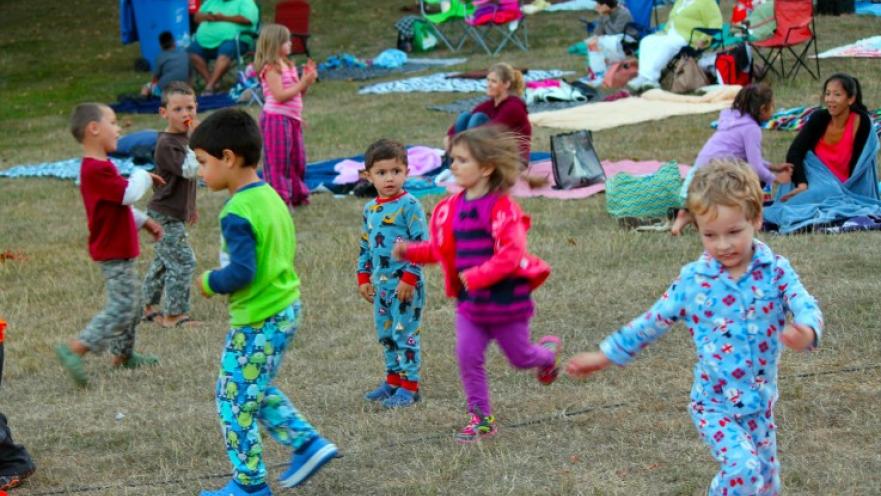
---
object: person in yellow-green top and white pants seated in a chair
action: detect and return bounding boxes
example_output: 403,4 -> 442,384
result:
627,0 -> 722,90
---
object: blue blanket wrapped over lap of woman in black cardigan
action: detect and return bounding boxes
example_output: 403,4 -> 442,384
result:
764,133 -> 881,234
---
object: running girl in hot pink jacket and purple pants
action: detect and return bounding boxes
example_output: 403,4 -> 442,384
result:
394,126 -> 562,443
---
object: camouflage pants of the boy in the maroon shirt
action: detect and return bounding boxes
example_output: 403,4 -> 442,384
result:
77,259 -> 141,357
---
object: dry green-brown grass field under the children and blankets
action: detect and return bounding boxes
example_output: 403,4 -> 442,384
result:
0,0 -> 881,495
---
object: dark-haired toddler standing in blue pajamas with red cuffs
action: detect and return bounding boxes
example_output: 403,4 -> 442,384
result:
358,139 -> 428,408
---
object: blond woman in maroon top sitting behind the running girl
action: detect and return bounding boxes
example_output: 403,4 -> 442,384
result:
444,63 -> 532,166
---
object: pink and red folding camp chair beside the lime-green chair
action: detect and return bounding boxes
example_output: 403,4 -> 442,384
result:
465,0 -> 529,55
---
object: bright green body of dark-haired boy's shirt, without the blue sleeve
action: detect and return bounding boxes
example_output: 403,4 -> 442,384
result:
220,184 -> 300,326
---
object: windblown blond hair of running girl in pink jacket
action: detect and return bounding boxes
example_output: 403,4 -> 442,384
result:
450,126 -> 523,192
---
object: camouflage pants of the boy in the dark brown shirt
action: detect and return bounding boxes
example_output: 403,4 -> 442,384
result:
144,210 -> 196,315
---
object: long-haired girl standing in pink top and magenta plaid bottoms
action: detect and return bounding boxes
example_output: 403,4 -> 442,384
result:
254,24 -> 318,207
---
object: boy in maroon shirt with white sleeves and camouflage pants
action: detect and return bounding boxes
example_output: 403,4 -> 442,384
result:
55,103 -> 165,386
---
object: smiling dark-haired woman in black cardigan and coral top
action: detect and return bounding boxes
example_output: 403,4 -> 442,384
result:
780,73 -> 877,201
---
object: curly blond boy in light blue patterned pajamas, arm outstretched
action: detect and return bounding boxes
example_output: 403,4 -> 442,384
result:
566,160 -> 823,496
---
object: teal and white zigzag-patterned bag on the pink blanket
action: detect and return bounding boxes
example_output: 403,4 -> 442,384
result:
606,162 -> 682,219
